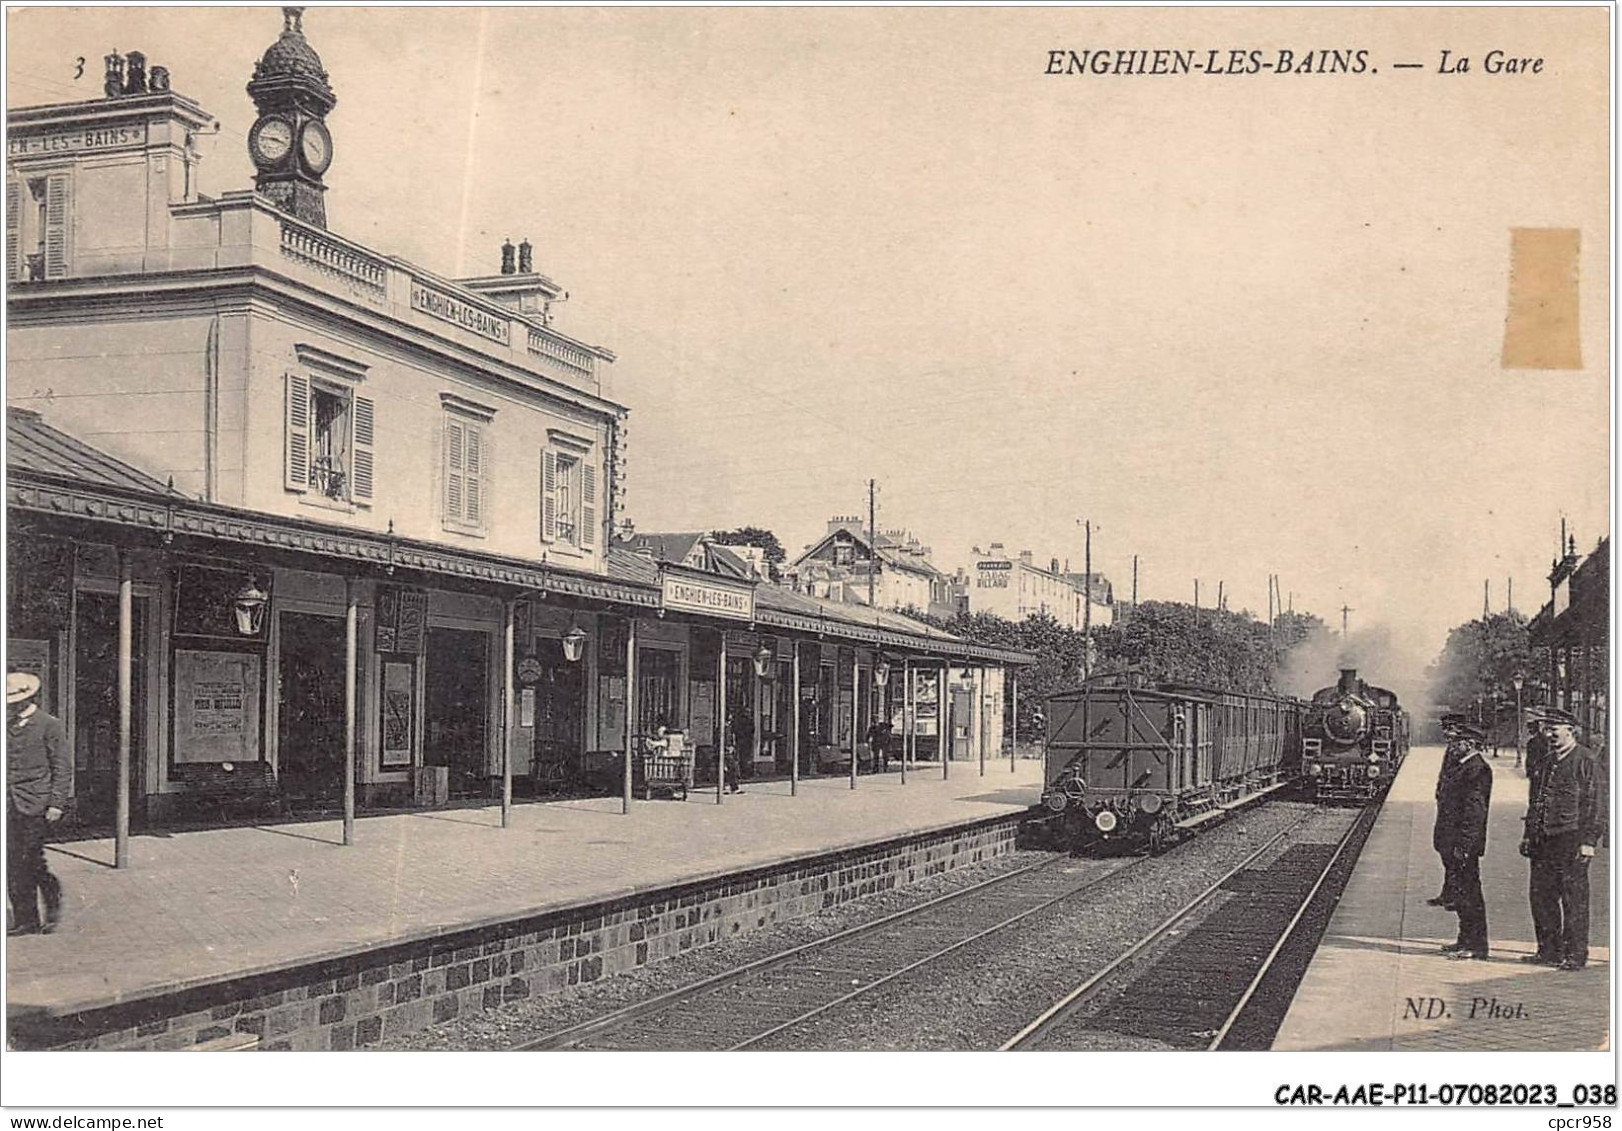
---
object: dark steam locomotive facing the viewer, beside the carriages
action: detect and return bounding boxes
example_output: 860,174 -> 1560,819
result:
1301,667 -> 1408,802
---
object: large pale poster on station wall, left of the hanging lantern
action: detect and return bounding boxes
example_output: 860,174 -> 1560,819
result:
174,649 -> 261,766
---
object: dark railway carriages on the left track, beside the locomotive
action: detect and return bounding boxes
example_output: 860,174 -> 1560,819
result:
1020,675 -> 1302,852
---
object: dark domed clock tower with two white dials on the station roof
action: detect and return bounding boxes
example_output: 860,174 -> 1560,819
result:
248,8 -> 337,227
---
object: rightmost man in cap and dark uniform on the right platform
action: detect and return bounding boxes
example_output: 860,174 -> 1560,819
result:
1520,707 -> 1609,970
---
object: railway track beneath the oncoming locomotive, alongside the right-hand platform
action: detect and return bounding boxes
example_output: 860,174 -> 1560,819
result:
1002,805 -> 1380,1050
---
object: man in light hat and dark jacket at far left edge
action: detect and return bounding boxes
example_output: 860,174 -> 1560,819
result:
5,672 -> 73,935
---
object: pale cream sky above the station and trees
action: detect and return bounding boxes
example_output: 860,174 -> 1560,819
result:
6,8 -> 1611,678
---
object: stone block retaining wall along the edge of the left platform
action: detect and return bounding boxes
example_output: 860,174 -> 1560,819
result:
19,816 -> 1019,1050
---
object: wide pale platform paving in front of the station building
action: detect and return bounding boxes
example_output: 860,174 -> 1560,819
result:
5,761 -> 1041,1014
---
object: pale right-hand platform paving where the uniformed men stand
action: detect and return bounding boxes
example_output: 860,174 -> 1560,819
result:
1273,746 -> 1611,1051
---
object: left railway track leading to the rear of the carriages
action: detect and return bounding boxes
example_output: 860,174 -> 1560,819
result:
513,855 -> 1142,1051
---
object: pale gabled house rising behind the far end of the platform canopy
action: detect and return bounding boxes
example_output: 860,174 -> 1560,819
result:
783,514 -> 959,618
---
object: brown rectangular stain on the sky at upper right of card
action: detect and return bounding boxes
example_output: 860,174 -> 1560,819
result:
1502,227 -> 1583,368
